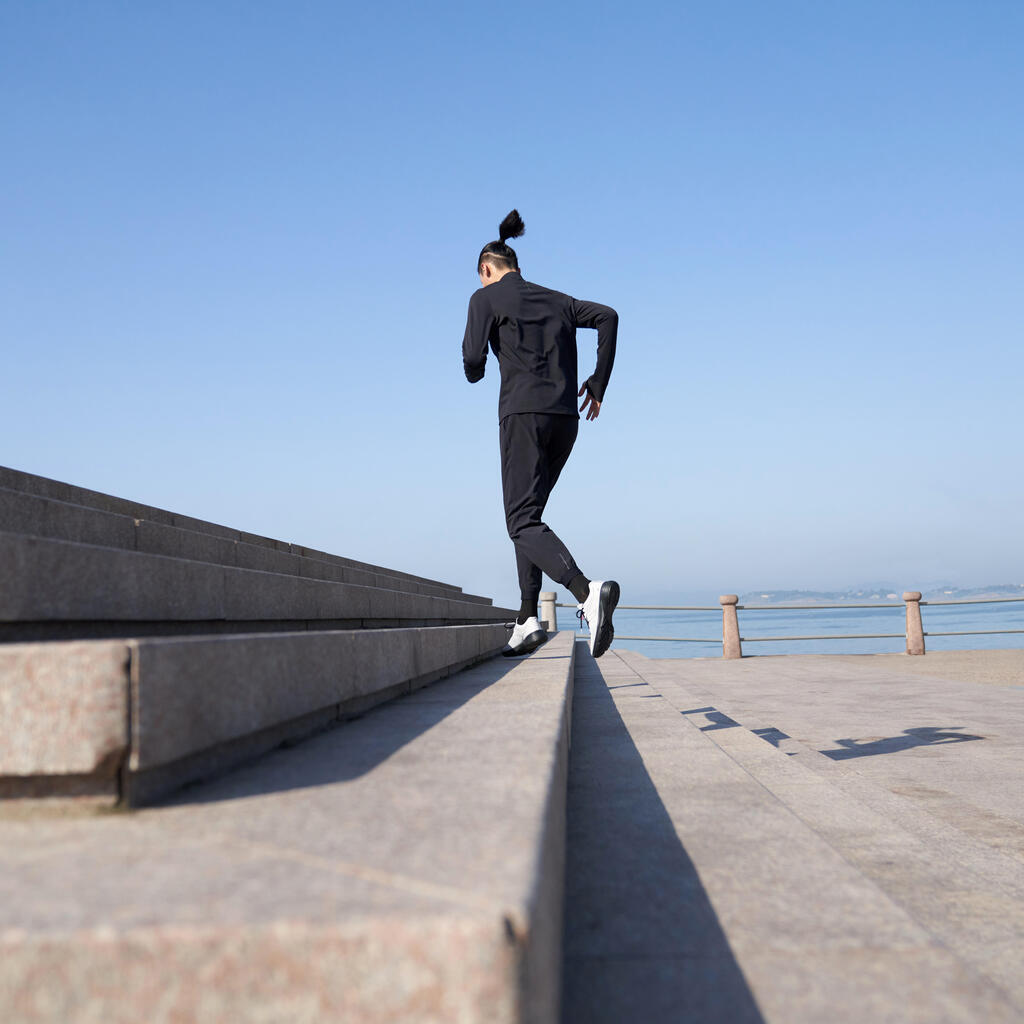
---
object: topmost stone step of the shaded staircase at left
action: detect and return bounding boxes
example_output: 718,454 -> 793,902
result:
0,466 -> 462,592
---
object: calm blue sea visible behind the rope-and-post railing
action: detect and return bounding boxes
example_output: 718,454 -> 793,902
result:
589,601 -> 1024,657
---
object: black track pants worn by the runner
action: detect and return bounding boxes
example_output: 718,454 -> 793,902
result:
500,413 -> 580,601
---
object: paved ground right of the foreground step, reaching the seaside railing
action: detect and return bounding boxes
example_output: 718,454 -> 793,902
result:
564,651 -> 1024,1024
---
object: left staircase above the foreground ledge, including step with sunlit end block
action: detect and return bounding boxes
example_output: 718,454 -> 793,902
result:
0,468 -> 514,806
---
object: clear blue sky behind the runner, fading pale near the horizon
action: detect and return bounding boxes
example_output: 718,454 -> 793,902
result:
0,0 -> 1024,602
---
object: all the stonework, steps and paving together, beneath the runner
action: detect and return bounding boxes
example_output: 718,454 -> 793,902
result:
0,468 -> 1024,1024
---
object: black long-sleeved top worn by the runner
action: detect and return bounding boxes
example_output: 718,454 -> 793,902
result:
462,271 -> 618,420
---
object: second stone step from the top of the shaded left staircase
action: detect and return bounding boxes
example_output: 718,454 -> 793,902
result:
0,481 -> 490,604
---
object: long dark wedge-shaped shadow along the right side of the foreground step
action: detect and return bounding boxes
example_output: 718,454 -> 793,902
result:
562,657 -> 764,1024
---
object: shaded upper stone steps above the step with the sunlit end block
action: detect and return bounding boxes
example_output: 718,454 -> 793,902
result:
0,468 -> 508,642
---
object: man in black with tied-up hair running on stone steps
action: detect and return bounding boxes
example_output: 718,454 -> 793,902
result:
462,210 -> 618,657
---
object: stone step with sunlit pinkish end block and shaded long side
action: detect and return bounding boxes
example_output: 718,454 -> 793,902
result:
0,626 -> 508,806
